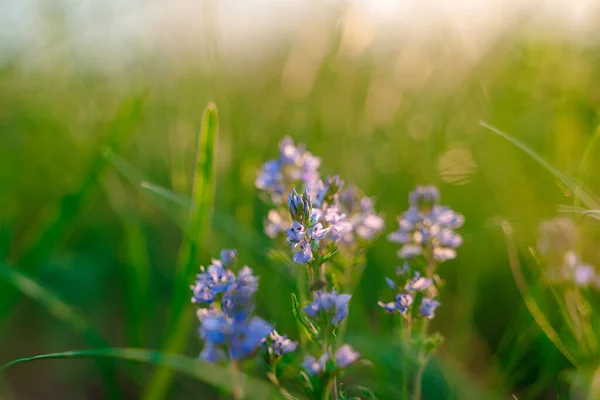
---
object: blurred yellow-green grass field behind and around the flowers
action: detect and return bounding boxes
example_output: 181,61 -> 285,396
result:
0,7 -> 600,400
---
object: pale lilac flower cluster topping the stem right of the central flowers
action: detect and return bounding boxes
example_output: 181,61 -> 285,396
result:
388,186 -> 464,262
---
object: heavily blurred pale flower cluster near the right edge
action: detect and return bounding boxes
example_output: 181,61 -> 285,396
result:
538,218 -> 600,289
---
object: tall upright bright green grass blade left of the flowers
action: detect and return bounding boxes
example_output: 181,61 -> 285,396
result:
143,103 -> 219,400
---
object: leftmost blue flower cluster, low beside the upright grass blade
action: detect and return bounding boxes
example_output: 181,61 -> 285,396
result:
191,250 -> 290,362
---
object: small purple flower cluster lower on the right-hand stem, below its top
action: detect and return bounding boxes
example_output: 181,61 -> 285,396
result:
378,264 -> 440,319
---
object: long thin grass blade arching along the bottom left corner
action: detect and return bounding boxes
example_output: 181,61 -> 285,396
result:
0,348 -> 277,400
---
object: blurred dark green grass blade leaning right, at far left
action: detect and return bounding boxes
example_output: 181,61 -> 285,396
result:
0,97 -> 143,322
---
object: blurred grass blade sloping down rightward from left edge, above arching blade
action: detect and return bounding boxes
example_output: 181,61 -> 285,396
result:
0,263 -> 123,399
